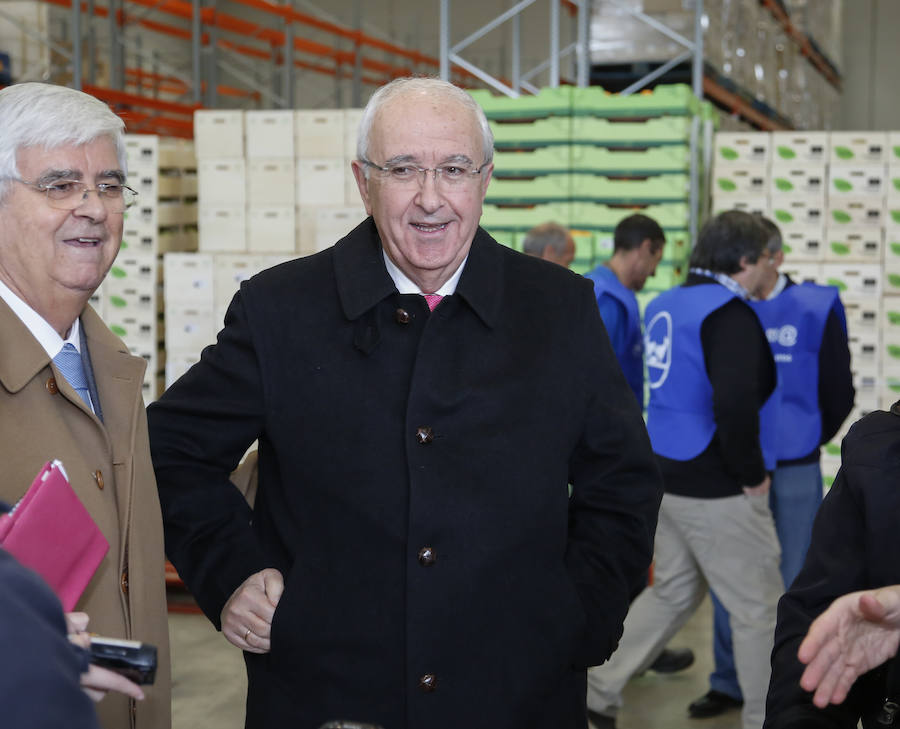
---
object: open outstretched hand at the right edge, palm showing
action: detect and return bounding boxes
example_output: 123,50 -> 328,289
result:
797,585 -> 900,708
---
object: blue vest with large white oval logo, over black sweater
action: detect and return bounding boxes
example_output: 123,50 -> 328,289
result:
644,284 -> 777,470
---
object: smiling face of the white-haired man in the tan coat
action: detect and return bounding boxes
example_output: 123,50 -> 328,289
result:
0,137 -> 124,333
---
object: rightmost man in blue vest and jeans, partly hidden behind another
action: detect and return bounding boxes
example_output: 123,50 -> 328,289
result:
688,213 -> 855,718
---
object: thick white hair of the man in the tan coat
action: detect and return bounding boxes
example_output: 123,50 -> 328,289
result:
0,82 -> 128,202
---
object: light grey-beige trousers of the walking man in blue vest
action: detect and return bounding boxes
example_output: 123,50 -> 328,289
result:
587,494 -> 784,729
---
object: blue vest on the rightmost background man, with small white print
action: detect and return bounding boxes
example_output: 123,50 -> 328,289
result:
751,283 -> 847,461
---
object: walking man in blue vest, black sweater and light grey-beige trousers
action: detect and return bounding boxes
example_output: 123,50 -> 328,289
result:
588,211 -> 783,729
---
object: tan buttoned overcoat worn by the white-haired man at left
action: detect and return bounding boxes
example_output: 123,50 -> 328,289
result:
0,300 -> 171,729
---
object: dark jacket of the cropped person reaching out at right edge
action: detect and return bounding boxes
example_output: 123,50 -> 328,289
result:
764,403 -> 900,729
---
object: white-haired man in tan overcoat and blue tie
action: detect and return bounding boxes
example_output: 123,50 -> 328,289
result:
0,83 -> 171,729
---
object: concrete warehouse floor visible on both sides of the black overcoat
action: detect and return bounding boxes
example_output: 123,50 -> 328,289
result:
169,599 -> 741,729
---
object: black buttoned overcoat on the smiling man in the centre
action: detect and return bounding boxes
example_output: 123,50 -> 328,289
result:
149,219 -> 661,729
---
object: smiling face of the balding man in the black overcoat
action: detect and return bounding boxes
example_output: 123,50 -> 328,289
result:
353,93 -> 493,293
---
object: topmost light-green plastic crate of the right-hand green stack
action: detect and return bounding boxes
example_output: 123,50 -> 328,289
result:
572,84 -> 700,118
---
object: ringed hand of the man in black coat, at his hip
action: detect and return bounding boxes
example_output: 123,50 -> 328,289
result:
221,568 -> 284,653
